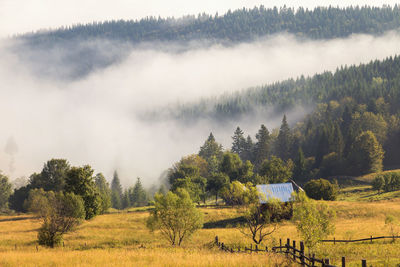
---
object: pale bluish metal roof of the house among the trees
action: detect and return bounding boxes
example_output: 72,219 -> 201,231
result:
257,183 -> 294,204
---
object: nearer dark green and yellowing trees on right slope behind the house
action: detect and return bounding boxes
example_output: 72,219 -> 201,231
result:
168,105 -> 390,204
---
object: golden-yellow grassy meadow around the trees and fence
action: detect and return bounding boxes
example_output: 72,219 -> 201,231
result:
0,199 -> 400,266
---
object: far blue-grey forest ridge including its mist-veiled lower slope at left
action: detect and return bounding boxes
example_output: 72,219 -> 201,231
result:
11,6 -> 400,79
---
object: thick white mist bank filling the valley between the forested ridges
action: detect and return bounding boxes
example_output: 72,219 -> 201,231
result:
0,33 -> 400,185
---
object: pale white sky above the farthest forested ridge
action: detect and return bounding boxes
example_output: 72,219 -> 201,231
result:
0,0 -> 397,37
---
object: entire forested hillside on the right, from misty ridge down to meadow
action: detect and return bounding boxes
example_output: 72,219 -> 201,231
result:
162,56 -> 400,197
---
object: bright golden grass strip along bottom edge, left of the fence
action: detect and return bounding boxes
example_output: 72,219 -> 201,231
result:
0,248 -> 294,267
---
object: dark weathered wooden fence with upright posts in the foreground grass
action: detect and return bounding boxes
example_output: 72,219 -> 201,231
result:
215,236 -> 367,267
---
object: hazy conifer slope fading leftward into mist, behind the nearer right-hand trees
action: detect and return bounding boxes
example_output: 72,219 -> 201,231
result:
166,56 -> 400,122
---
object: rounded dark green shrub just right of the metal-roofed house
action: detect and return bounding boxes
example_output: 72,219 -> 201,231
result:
304,179 -> 339,200
